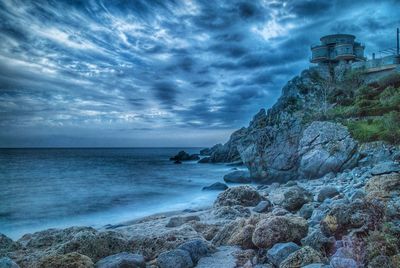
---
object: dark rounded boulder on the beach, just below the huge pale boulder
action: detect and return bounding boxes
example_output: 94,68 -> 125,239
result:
282,186 -> 313,212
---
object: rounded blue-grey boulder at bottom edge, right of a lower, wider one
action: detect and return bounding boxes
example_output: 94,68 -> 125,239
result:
157,249 -> 193,268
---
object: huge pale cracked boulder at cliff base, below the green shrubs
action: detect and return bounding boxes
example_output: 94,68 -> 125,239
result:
299,121 -> 359,178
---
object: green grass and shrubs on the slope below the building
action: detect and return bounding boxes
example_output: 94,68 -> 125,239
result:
326,73 -> 400,144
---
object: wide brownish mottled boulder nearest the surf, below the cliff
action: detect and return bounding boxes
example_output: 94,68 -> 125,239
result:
214,186 -> 262,207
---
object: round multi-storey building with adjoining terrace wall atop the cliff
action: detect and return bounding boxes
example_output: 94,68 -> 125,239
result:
310,29 -> 400,79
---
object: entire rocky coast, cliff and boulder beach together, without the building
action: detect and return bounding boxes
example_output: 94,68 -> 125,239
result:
0,36 -> 400,268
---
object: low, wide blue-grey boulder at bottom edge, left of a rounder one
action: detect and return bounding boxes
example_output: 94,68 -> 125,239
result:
96,252 -> 146,268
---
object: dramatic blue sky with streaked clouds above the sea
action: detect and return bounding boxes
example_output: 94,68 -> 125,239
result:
0,0 -> 400,147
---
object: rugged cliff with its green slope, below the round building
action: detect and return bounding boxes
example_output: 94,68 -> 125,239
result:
202,69 -> 400,182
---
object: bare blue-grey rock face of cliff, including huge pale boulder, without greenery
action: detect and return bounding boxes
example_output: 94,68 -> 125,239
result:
203,70 -> 358,182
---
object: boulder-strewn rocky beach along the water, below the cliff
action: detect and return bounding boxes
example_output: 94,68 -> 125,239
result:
0,152 -> 400,268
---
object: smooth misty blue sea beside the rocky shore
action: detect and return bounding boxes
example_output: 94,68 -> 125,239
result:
0,148 -> 236,239
